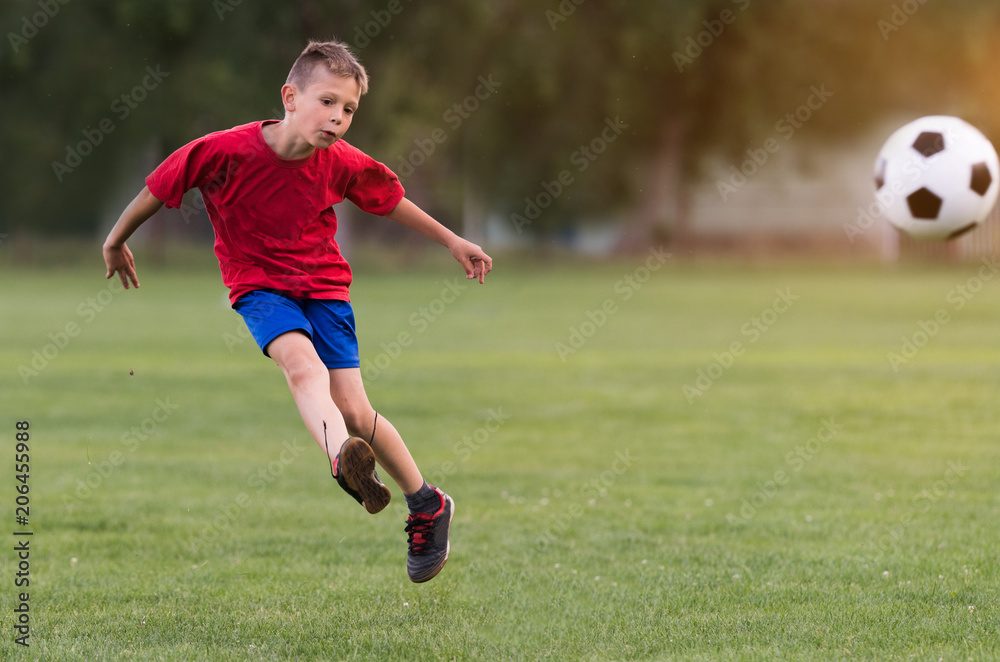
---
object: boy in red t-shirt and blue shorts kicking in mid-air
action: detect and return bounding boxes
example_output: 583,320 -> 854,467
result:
104,42 -> 493,582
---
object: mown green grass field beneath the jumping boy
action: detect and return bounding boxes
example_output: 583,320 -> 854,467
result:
0,256 -> 1000,661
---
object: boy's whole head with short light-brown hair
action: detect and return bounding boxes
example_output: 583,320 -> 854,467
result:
281,41 -> 368,149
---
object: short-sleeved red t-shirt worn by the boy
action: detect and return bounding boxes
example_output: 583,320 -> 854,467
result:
146,120 -> 403,303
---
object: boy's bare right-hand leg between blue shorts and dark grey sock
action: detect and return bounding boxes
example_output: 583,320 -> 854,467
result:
329,368 -> 424,494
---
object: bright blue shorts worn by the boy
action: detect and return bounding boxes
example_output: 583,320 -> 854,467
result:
233,290 -> 361,369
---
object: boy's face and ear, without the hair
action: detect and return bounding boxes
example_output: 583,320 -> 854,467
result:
283,67 -> 361,149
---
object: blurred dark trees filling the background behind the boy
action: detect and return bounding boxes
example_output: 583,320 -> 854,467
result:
0,0 -> 1000,249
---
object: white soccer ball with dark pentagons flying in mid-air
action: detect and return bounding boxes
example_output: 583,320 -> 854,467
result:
875,115 -> 1000,241
